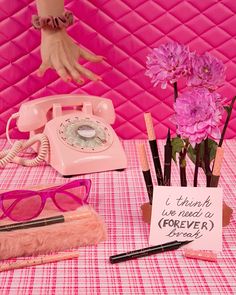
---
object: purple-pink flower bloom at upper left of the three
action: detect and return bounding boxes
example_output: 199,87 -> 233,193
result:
145,42 -> 191,89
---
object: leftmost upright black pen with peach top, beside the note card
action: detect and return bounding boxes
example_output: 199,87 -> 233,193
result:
137,144 -> 153,205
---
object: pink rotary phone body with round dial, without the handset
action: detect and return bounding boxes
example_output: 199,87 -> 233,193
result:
44,112 -> 127,176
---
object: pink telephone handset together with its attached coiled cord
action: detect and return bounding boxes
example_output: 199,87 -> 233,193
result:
0,95 -> 115,168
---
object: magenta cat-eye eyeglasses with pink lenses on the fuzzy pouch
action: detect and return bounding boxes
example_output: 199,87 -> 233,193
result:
0,179 -> 91,221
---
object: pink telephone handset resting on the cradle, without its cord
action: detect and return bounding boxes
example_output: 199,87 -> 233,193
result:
17,94 -> 115,132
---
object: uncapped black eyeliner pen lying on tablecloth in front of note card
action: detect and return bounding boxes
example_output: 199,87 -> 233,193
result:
110,241 -> 192,263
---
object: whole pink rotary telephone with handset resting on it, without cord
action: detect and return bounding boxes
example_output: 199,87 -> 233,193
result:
17,95 -> 127,176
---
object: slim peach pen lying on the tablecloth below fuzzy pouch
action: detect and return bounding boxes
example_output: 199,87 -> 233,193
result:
0,251 -> 79,272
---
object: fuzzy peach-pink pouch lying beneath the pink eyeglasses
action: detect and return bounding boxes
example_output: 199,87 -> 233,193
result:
0,205 -> 107,259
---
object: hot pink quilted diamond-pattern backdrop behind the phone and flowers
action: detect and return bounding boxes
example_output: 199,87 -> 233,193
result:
0,0 -> 236,138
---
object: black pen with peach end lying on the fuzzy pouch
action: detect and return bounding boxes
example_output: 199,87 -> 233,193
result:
0,211 -> 87,232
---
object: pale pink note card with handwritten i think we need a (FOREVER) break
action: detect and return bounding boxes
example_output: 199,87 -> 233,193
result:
149,186 -> 223,251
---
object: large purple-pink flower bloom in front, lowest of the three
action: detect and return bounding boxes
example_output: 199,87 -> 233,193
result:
174,88 -> 223,146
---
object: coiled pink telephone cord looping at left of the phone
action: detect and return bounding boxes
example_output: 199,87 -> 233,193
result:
0,113 -> 49,168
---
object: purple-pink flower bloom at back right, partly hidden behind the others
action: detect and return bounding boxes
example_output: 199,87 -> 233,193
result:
188,53 -> 225,91
